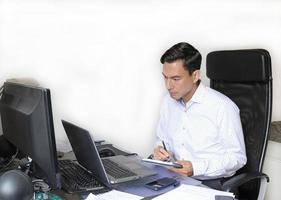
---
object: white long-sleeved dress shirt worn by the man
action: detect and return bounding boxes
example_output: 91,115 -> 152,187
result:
156,83 -> 247,180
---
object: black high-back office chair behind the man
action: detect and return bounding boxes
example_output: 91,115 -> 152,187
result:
207,49 -> 272,200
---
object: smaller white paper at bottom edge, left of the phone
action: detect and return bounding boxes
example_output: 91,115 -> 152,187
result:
86,190 -> 143,200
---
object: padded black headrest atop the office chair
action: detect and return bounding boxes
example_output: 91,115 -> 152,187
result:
206,49 -> 272,82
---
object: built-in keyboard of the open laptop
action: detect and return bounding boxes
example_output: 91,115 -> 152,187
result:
102,159 -> 137,179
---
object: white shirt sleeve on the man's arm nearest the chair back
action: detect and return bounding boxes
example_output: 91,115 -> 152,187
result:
191,102 -> 247,178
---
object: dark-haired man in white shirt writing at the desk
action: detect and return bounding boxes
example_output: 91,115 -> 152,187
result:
153,43 -> 247,188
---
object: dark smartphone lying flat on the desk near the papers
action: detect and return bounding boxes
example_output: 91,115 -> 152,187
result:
145,177 -> 177,191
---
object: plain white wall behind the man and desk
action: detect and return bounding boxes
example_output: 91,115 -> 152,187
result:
0,0 -> 281,156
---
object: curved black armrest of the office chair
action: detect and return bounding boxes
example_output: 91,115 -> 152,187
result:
222,172 -> 269,192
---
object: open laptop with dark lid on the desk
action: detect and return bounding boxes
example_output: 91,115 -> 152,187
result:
62,120 -> 157,186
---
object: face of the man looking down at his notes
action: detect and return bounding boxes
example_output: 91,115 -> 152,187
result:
162,60 -> 199,103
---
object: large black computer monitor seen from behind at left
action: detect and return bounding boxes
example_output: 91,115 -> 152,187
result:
0,82 -> 60,188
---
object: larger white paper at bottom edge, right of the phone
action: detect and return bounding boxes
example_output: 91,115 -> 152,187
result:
153,184 -> 234,200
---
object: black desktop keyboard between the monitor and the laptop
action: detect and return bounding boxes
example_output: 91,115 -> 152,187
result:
58,160 -> 110,194
